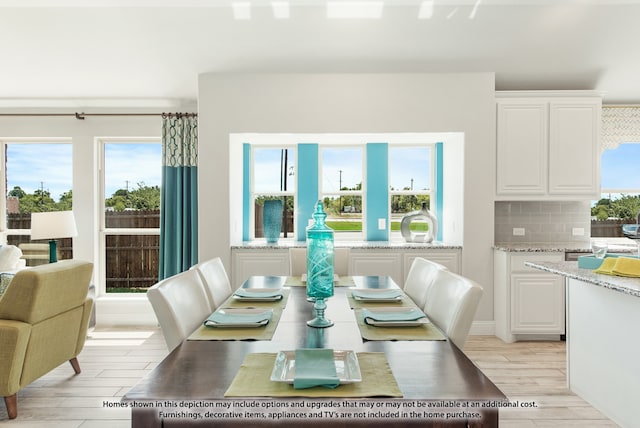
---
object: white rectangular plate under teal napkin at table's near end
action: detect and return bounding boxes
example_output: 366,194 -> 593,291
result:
271,350 -> 362,384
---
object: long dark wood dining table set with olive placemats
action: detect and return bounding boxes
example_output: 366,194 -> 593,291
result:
121,276 -> 508,428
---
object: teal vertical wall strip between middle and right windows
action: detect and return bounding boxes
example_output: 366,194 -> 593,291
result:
366,143 -> 389,241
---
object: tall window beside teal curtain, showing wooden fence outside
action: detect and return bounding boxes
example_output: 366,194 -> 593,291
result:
101,139 -> 162,293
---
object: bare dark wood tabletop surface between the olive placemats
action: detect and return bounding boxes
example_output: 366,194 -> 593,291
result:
123,277 -> 505,424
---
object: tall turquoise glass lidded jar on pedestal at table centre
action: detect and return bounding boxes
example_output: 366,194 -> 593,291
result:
307,201 -> 333,328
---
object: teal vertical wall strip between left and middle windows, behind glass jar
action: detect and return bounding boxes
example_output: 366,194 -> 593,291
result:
296,143 -> 319,241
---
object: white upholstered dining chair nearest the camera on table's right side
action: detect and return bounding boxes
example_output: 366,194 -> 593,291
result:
424,269 -> 483,349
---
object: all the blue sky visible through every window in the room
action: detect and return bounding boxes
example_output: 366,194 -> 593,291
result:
7,143 -> 640,200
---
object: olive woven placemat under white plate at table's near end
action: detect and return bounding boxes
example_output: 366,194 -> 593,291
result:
224,352 -> 402,398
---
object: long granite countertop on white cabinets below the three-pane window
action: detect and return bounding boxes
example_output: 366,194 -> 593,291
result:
231,239 -> 462,250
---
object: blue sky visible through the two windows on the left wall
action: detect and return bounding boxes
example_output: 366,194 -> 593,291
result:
7,143 -> 162,201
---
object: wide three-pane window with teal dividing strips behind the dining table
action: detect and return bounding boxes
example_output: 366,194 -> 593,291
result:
244,137 -> 437,241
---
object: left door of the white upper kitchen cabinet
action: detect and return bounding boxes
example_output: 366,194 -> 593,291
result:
497,100 -> 548,195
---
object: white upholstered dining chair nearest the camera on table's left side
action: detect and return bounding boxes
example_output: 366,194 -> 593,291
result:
147,269 -> 212,351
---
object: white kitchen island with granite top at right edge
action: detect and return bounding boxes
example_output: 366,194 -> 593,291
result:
526,262 -> 640,427
